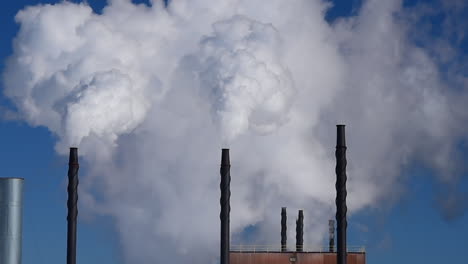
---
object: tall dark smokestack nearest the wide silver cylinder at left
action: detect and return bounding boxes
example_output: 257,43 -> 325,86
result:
67,148 -> 80,264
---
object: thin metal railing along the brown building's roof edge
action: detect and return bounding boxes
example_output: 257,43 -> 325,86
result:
230,245 -> 366,253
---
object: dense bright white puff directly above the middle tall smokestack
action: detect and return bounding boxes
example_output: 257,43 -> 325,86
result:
181,15 -> 295,140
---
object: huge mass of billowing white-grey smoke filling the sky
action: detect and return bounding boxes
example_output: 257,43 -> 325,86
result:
4,0 -> 468,264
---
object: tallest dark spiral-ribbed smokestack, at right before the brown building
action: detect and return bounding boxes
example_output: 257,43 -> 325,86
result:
335,125 -> 348,264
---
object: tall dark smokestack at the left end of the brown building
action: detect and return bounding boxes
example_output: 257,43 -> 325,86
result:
219,149 -> 231,264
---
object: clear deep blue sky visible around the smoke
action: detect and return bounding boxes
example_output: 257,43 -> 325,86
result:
0,0 -> 468,264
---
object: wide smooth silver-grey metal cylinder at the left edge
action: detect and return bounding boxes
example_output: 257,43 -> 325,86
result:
0,178 -> 24,264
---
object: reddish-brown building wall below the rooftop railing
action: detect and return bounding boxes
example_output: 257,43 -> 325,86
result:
229,252 -> 366,264
